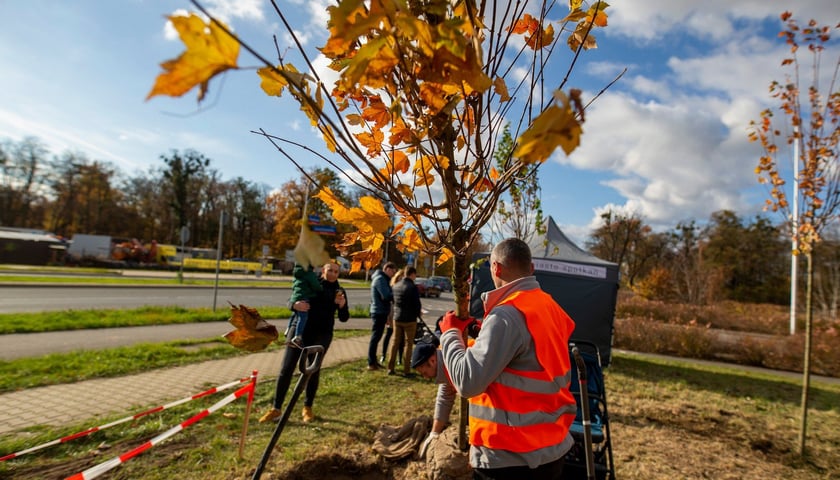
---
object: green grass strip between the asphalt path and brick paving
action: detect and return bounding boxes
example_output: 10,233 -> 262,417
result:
0,330 -> 368,393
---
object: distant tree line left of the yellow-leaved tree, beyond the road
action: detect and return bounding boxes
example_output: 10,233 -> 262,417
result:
0,137 -> 273,257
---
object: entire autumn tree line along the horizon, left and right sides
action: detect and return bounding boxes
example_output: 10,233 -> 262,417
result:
0,137 -> 840,318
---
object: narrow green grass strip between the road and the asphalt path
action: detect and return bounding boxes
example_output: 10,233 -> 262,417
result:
0,306 -> 370,335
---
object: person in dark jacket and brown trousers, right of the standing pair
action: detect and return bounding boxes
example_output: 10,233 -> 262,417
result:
388,266 -> 421,377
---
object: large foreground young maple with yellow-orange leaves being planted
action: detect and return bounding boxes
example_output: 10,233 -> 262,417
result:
148,0 -> 608,322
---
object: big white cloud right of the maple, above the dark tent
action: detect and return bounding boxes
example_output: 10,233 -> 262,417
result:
560,94 -> 755,231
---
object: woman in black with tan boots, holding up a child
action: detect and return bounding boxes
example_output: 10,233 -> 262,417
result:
260,263 -> 350,423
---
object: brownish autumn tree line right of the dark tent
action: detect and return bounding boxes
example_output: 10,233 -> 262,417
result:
586,210 -> 840,319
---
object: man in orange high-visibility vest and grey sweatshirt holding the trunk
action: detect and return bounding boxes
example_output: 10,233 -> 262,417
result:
440,238 -> 577,480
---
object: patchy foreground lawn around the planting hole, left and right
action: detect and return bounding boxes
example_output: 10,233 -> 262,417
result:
0,354 -> 840,480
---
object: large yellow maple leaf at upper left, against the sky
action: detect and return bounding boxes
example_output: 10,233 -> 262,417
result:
146,14 -> 239,101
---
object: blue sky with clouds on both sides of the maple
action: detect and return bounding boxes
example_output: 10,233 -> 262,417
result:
0,0 -> 840,246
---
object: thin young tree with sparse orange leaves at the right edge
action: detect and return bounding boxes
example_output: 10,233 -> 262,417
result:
750,12 -> 840,455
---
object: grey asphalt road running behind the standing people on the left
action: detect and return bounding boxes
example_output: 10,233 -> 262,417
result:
0,284 -> 454,318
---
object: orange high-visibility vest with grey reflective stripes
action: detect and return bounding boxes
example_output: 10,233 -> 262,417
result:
469,289 -> 576,453
